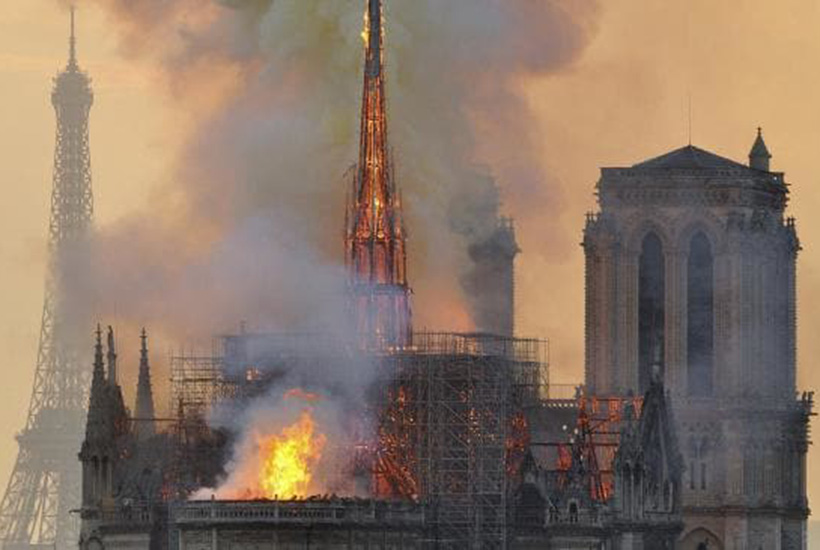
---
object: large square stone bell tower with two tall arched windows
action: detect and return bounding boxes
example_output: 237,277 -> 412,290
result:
583,132 -> 812,550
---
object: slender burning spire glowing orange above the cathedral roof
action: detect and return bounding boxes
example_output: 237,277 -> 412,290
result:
345,0 -> 411,348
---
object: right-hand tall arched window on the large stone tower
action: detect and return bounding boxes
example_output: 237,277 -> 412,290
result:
686,233 -> 715,396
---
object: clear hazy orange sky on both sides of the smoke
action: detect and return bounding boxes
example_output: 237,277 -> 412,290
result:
0,0 -> 820,532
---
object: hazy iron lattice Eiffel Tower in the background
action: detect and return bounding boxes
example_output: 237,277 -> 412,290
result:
0,9 -> 93,550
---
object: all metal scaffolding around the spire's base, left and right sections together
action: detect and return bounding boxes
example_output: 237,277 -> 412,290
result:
171,332 -> 549,549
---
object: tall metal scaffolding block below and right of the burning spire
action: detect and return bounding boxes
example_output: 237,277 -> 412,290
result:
376,333 -> 547,549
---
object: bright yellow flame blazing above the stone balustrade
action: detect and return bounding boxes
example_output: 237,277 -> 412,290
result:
258,409 -> 327,499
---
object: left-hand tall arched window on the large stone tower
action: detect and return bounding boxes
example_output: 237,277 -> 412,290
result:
638,233 -> 666,393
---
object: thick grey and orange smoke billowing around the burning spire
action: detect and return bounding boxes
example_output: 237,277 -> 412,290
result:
57,0 -> 597,398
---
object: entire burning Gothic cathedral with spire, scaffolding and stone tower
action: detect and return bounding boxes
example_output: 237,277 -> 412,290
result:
73,0 -> 812,550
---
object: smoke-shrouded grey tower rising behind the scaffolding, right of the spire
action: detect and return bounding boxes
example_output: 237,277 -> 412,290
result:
464,218 -> 521,337
